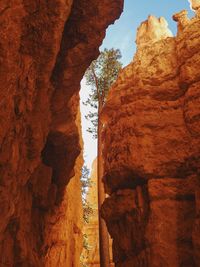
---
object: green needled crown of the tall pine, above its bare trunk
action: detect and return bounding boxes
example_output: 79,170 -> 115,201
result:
84,48 -> 122,139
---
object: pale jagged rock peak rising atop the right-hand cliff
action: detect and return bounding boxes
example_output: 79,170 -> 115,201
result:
136,15 -> 173,46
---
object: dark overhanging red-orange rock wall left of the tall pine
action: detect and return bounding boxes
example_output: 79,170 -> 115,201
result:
0,0 -> 123,267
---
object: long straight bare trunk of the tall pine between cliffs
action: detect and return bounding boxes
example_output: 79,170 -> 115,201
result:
97,101 -> 110,267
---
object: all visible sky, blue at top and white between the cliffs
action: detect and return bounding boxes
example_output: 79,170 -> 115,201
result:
80,0 -> 195,171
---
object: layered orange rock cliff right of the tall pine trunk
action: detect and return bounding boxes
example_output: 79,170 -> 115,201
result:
101,11 -> 200,267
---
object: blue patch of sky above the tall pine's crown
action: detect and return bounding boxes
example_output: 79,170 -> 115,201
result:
101,0 -> 192,65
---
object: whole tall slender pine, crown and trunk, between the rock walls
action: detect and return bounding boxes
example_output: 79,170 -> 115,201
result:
85,48 -> 122,267
